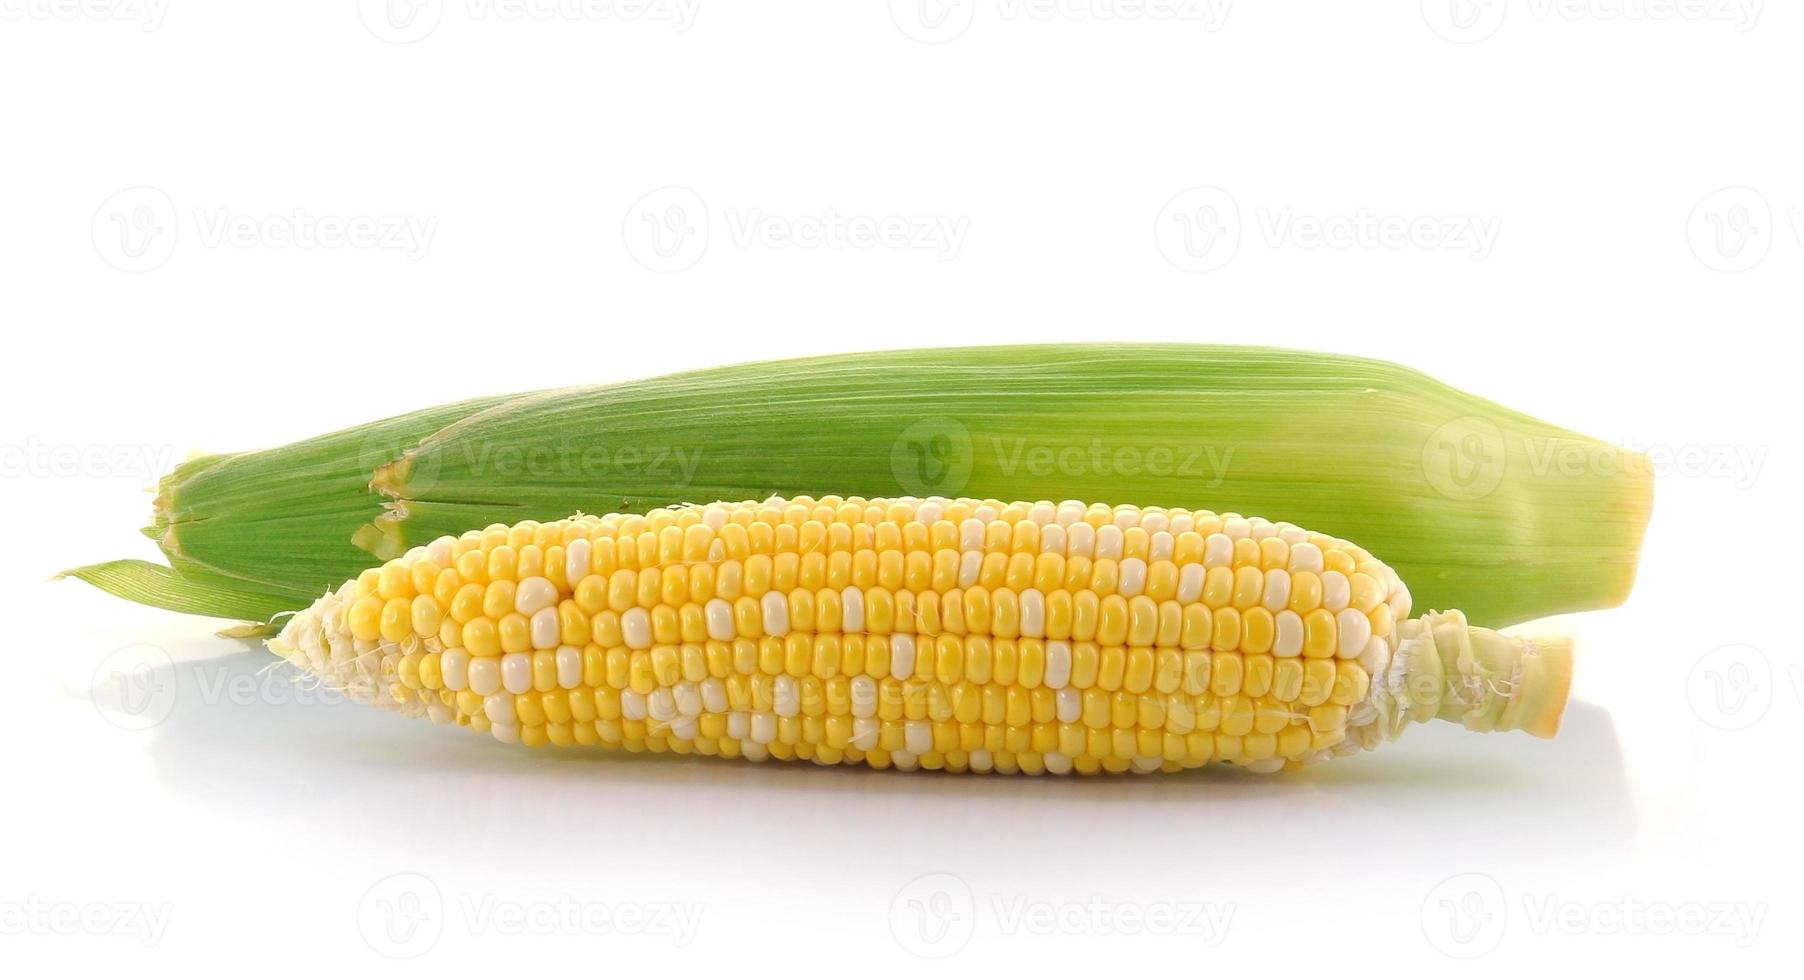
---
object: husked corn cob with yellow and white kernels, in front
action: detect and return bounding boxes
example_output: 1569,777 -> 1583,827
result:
269,496 -> 1571,772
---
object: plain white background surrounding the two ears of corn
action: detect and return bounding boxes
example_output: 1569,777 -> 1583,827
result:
0,0 -> 1804,976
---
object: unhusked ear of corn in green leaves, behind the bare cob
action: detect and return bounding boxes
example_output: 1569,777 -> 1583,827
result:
70,345 -> 1652,624
